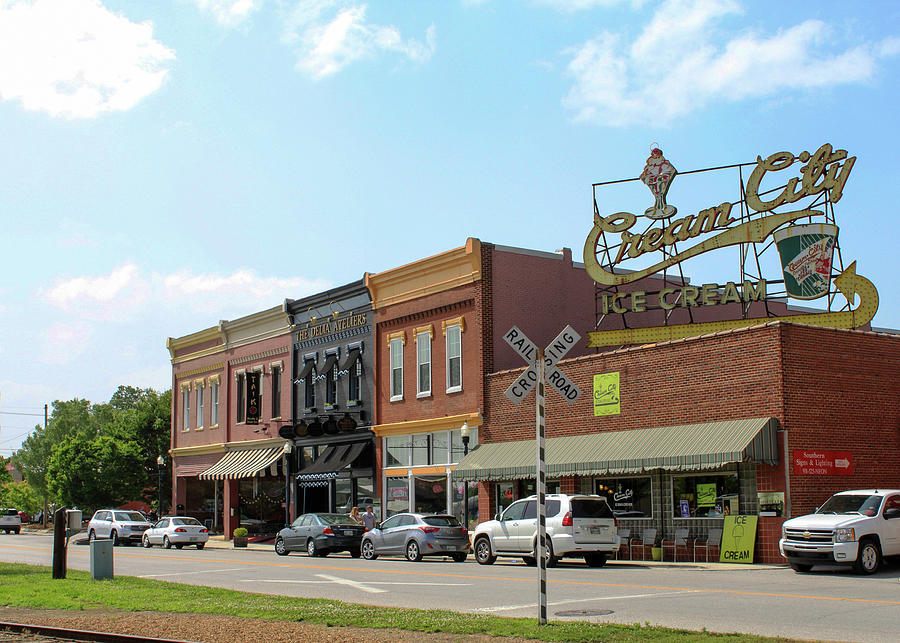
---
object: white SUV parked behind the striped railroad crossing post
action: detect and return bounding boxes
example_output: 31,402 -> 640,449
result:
473,494 -> 619,567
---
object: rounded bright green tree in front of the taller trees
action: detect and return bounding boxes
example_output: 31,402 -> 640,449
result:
47,434 -> 143,510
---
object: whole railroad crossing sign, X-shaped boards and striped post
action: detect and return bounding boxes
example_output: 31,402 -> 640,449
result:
503,326 -> 581,625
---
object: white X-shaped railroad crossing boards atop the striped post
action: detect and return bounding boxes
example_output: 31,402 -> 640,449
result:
503,326 -> 581,406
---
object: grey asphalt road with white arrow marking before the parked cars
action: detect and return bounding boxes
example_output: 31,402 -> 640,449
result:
0,533 -> 900,642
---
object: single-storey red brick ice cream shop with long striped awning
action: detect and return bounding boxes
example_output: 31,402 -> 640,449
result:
454,321 -> 900,562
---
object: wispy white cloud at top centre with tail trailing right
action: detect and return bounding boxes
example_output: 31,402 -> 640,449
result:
284,0 -> 435,79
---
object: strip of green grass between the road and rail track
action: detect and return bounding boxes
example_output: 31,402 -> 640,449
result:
0,563 -> 800,643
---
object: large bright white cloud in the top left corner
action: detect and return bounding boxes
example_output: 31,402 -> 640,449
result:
0,0 -> 175,118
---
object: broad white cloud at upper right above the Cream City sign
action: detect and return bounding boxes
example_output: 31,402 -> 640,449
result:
563,0 -> 900,126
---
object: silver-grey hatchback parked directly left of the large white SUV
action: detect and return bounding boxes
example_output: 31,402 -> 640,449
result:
362,513 -> 469,563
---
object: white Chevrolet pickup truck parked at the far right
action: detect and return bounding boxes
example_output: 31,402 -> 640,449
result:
778,489 -> 900,574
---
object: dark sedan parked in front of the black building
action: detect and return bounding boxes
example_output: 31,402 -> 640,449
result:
275,513 -> 365,558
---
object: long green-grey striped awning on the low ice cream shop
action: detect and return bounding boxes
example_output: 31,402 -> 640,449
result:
453,418 -> 778,480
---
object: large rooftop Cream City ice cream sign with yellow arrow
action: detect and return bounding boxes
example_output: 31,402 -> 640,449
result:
584,143 -> 878,346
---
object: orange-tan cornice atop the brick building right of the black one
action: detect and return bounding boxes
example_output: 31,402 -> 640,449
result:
365,237 -> 481,310
